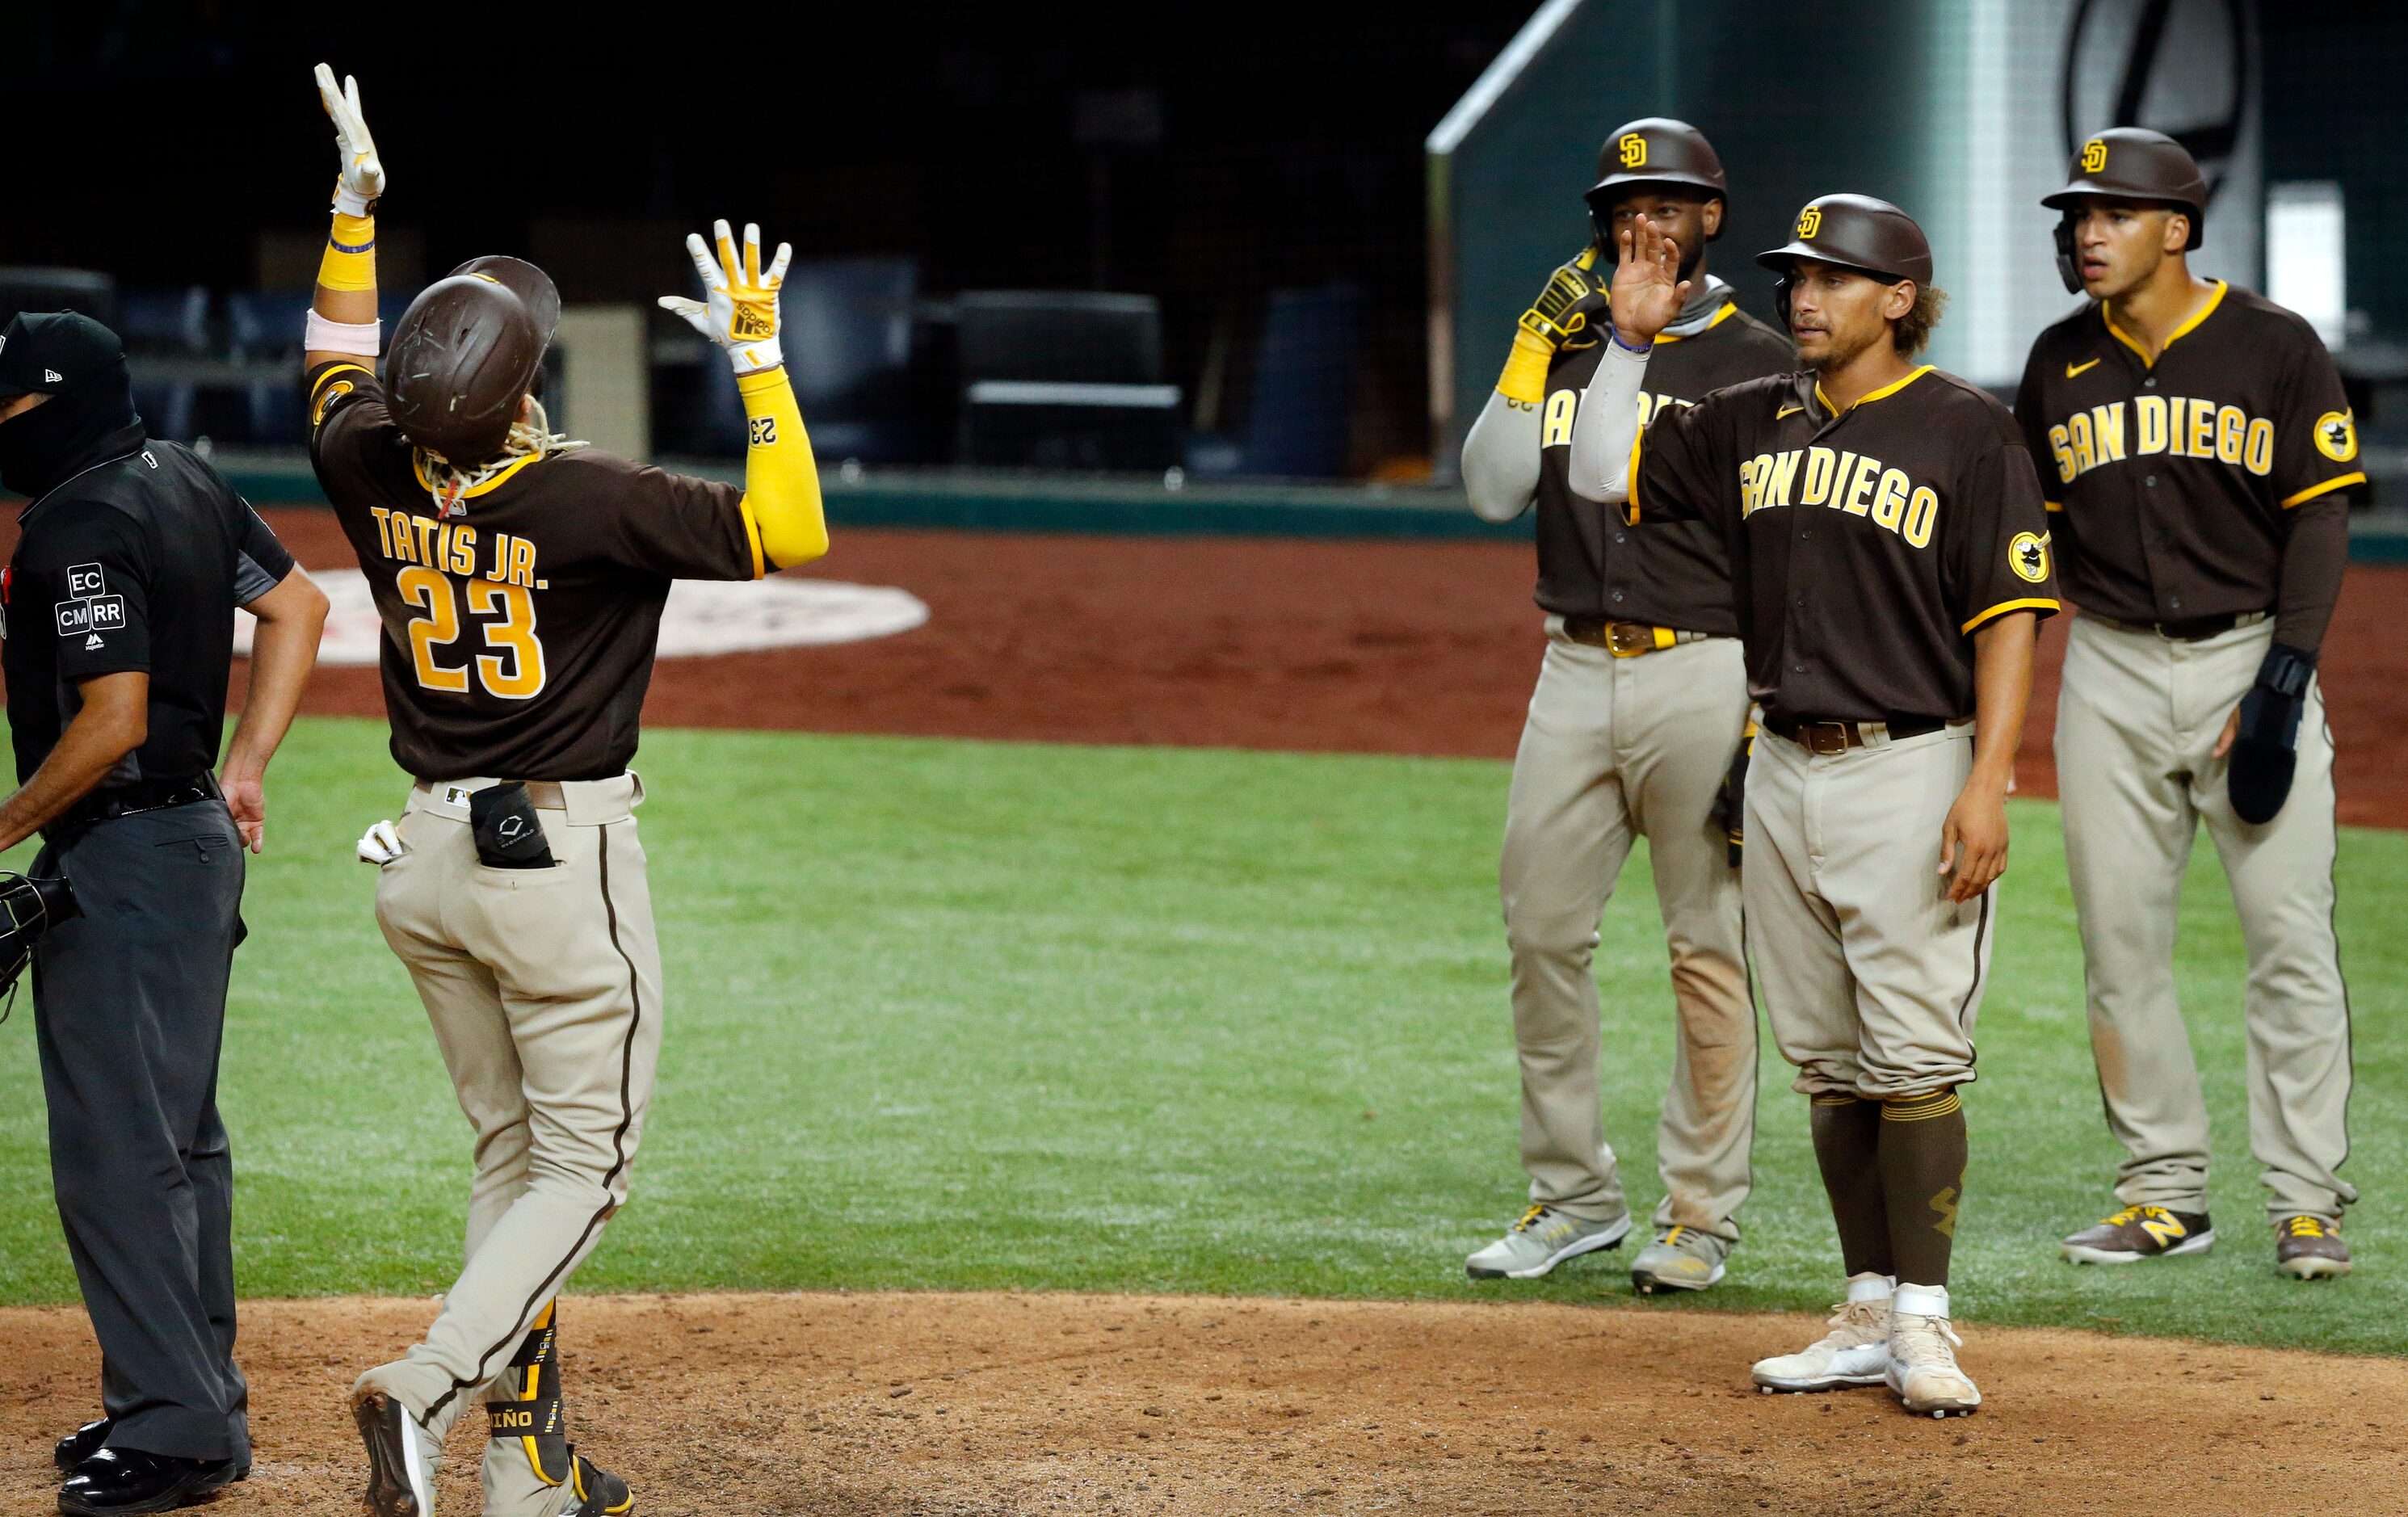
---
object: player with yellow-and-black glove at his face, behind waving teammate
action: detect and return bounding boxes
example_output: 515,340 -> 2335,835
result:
1464,116 -> 1794,1291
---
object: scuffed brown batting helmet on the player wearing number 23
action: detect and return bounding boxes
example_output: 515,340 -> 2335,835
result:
385,258 -> 561,469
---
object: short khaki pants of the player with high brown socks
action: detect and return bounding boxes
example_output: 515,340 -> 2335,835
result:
1743,722 -> 1998,1100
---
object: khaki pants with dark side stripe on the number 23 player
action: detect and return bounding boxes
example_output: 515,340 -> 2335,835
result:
361,775 -> 662,1517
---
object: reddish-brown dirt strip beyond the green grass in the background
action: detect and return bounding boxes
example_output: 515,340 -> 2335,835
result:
249,511 -> 2408,826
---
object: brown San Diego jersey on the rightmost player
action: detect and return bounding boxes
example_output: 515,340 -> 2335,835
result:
2015,282 -> 2367,624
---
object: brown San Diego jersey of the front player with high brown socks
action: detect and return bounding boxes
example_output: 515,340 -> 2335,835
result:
1628,361 -> 2057,722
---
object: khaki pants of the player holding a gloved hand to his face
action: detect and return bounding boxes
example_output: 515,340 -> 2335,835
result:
1500,619 -> 1755,1242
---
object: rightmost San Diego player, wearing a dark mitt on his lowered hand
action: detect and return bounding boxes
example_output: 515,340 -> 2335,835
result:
2015,128 -> 2367,1279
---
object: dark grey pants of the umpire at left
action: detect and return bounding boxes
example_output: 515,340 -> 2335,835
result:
34,797 -> 250,1464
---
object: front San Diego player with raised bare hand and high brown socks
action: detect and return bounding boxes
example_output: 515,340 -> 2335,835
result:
1570,195 -> 2057,1416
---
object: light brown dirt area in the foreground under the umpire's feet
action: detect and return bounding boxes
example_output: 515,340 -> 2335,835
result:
0,1286 -> 2408,1517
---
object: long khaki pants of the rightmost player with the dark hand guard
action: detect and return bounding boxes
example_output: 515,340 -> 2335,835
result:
2057,616 -> 2357,1223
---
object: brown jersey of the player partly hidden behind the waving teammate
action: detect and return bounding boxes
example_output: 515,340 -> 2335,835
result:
1536,301 -> 1797,636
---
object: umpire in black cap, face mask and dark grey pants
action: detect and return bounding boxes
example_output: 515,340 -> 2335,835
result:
0,311 -> 325,1512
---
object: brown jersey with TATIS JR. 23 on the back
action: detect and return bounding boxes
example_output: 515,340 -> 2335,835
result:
309,361 -> 761,780
